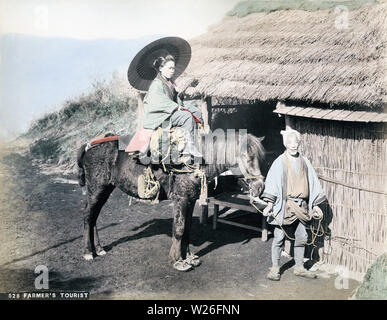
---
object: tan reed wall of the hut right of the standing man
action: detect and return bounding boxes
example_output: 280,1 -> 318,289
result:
291,118 -> 387,273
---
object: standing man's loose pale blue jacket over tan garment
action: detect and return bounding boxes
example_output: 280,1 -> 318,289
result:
261,152 -> 326,225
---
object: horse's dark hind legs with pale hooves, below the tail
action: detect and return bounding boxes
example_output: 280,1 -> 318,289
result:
83,185 -> 115,260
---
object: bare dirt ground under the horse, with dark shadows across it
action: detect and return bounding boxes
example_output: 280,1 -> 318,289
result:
0,141 -> 358,299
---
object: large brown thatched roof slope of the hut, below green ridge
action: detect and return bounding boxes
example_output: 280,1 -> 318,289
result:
178,3 -> 387,107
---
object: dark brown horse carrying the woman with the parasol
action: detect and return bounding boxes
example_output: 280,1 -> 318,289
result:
77,132 -> 265,270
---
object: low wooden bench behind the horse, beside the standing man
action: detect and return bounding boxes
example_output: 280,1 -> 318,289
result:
207,193 -> 268,241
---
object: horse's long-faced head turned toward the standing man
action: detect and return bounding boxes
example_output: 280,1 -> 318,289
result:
238,134 -> 265,198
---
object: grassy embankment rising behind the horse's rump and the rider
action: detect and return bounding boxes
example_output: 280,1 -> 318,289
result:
23,75 -> 137,173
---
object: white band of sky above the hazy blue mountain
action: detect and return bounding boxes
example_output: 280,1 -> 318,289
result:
0,0 -> 239,39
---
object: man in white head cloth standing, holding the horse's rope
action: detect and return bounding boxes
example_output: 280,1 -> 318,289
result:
261,129 -> 326,281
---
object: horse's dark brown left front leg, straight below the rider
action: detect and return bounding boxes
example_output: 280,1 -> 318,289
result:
169,198 -> 189,263
